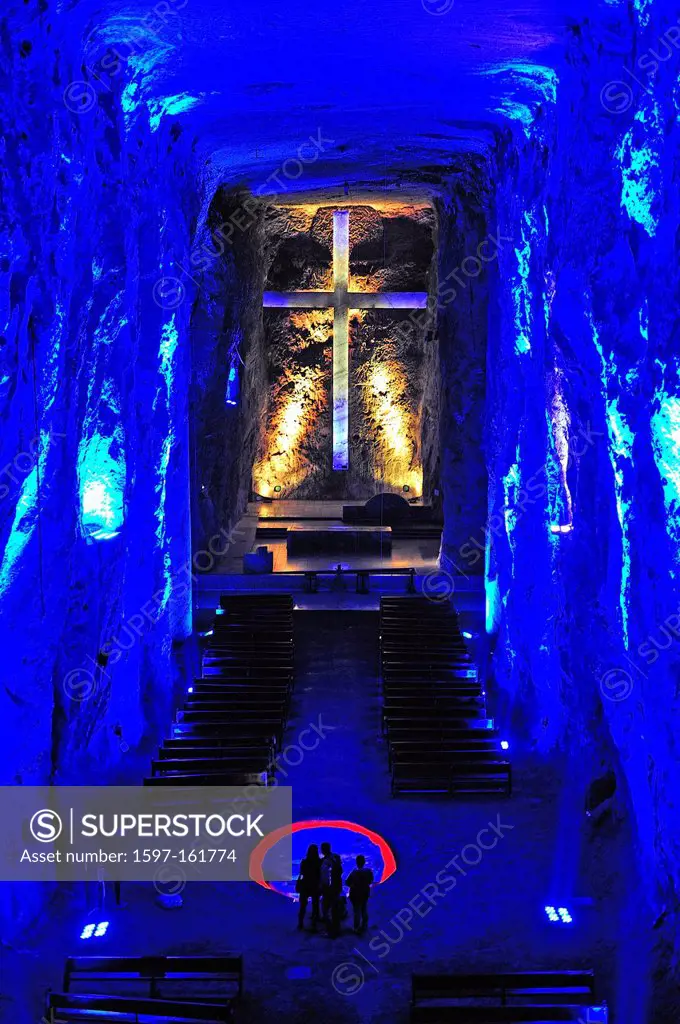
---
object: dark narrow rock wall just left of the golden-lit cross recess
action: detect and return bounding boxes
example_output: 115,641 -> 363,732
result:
190,187 -> 268,548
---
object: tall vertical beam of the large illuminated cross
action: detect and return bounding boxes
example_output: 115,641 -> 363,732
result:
333,210 -> 349,470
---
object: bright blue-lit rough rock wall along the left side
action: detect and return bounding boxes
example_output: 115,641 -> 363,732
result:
0,2 -> 195,934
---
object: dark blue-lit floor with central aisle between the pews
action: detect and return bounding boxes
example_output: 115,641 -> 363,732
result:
0,610 -> 645,1024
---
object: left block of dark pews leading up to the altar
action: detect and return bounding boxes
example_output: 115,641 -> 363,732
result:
144,594 -> 294,785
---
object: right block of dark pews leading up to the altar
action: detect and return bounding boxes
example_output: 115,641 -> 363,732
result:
380,596 -> 512,796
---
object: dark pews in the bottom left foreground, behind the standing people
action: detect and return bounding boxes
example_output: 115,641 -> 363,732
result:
45,953 -> 243,1024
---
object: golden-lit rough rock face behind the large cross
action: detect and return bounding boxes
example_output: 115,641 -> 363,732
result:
253,203 -> 434,499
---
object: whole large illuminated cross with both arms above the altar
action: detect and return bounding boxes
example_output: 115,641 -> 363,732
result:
264,210 -> 427,469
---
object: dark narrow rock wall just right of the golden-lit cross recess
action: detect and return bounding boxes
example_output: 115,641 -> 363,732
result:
432,165 -> 499,575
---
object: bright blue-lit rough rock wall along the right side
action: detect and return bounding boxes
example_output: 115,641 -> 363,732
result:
487,4 -> 680,1024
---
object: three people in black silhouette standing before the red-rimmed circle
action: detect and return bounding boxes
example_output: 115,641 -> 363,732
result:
295,843 -> 374,938
